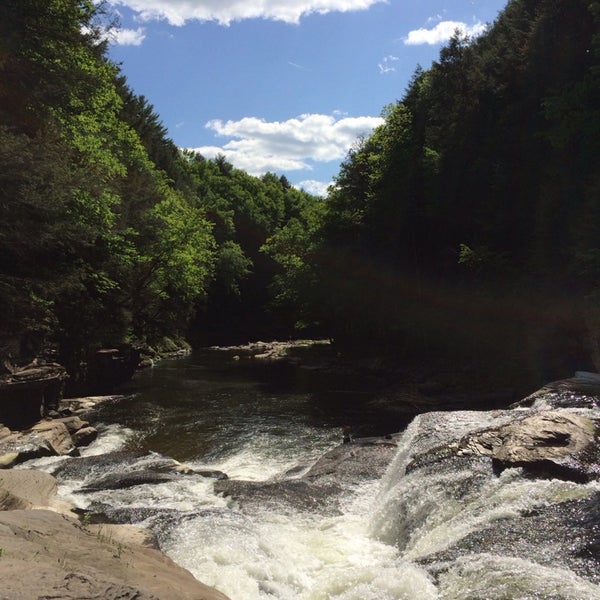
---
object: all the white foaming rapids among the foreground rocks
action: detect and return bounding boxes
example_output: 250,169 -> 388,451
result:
25,411 -> 600,600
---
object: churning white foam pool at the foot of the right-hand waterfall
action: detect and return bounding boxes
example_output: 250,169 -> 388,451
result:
164,476 -> 437,600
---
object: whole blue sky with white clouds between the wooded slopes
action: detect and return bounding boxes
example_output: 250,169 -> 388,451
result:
109,0 -> 507,195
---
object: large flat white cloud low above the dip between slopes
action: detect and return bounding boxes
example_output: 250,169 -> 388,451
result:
193,114 -> 383,175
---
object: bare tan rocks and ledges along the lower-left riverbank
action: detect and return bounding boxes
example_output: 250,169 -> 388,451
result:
0,396 -> 227,600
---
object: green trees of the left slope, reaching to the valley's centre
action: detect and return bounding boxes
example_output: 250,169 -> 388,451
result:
0,0 -> 322,379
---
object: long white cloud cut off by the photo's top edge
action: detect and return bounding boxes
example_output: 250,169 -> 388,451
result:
111,0 -> 387,26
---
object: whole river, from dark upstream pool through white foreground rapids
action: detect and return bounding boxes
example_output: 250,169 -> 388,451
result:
25,354 -> 600,600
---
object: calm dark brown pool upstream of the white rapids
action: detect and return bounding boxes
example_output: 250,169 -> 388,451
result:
98,352 -> 392,462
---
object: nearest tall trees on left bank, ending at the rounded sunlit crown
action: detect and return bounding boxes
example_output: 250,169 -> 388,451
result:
0,0 -> 215,379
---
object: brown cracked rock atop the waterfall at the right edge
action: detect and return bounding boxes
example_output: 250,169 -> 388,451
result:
457,409 -> 600,482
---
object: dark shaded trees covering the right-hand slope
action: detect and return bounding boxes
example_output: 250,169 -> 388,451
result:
268,0 -> 600,381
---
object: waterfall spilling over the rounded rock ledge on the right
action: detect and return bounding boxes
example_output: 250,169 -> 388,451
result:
369,411 -> 600,600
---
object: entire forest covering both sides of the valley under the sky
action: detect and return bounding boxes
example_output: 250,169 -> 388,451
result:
0,0 -> 600,390
